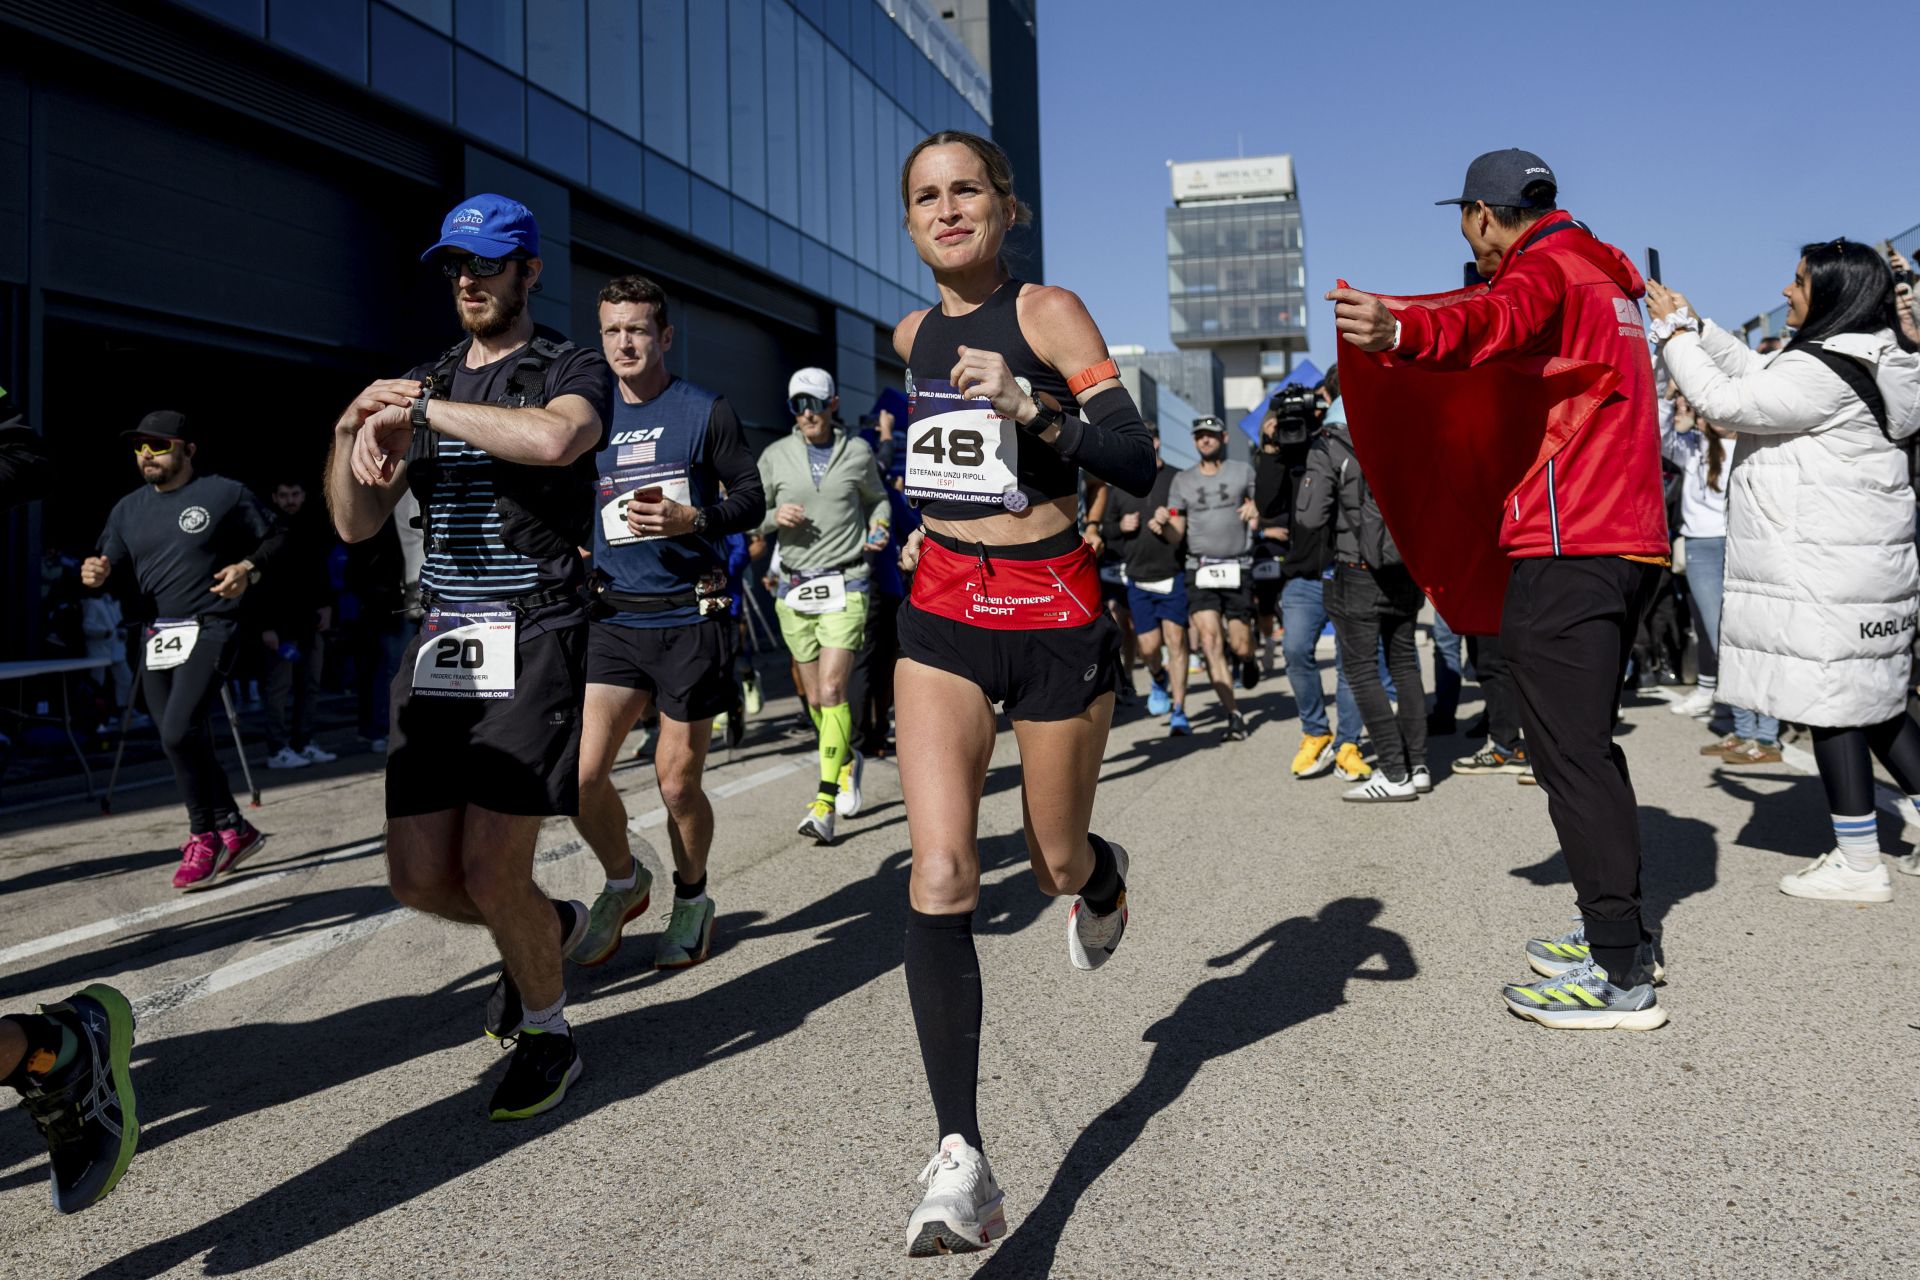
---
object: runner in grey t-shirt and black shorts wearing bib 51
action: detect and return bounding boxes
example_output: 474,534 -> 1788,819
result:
1167,416 -> 1260,743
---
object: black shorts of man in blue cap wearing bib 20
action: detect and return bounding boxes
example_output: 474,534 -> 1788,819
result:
386,601 -> 588,818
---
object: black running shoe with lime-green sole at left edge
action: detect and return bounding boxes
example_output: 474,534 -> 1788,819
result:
19,983 -> 140,1213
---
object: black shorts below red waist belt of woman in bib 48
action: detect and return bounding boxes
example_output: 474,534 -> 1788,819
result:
900,601 -> 1119,720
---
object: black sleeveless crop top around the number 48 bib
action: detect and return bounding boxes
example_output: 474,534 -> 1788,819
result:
906,278 -> 1079,520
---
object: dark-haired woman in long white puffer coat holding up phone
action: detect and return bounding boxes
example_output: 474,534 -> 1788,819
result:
1647,240 -> 1920,902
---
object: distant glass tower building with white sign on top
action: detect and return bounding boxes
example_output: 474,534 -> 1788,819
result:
1167,155 -> 1308,416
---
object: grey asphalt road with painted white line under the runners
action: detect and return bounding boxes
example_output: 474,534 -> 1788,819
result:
0,644 -> 1920,1280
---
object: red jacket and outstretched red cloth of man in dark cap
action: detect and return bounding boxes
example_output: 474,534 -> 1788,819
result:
1340,213 -> 1668,633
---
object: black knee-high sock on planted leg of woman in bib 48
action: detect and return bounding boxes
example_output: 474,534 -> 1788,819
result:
906,908 -> 985,1150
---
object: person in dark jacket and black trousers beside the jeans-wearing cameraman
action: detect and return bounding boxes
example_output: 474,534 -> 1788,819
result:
1294,384 -> 1432,804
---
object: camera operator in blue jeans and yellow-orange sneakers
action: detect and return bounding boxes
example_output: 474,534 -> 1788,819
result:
1254,378 -> 1373,781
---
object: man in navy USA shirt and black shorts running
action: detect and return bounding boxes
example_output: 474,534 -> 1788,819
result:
568,276 -> 766,969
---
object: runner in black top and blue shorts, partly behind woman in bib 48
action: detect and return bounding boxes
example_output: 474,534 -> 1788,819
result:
1100,426 -> 1188,737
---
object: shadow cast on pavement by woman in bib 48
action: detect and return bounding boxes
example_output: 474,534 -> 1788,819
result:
973,898 -> 1419,1278
